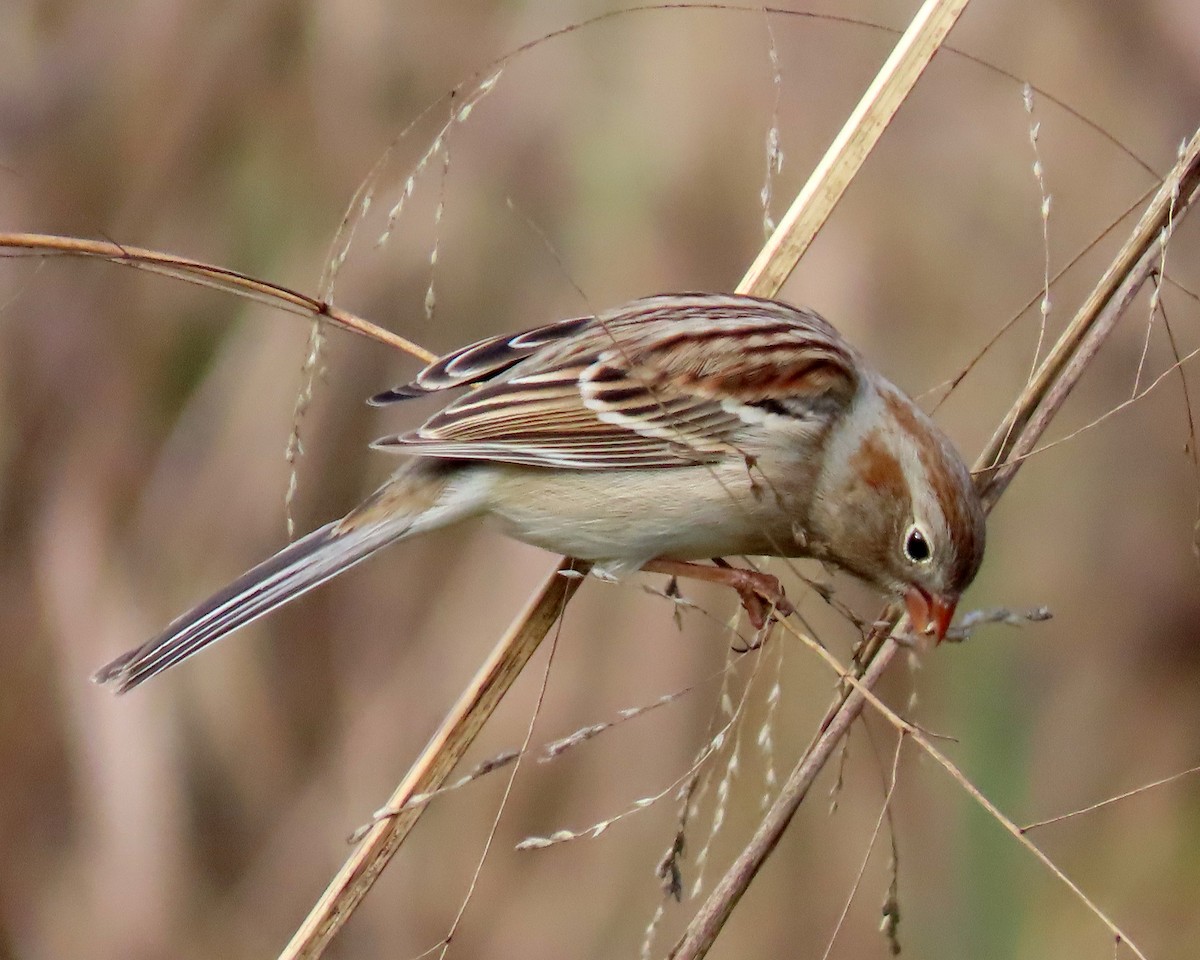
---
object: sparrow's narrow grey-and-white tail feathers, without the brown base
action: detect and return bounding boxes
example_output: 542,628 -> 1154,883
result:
92,517 -> 413,694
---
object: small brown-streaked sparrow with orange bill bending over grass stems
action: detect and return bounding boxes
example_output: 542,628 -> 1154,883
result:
94,293 -> 985,691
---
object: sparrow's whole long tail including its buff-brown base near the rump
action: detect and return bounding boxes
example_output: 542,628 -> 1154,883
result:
92,461 -> 475,694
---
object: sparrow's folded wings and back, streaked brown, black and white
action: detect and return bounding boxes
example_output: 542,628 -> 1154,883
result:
377,294 -> 857,469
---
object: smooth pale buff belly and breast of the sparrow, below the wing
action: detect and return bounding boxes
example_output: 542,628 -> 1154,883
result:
477,463 -> 806,569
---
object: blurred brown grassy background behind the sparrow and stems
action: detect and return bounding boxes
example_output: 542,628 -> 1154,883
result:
0,0 -> 1200,959
